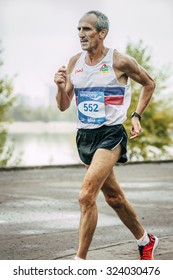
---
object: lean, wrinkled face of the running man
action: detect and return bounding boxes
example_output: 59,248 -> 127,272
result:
78,14 -> 100,51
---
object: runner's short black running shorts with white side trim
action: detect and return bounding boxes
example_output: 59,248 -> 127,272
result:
76,124 -> 127,165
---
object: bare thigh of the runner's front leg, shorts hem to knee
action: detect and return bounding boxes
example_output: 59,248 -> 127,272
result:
83,145 -> 121,195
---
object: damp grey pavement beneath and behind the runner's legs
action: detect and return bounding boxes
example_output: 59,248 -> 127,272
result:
0,162 -> 173,260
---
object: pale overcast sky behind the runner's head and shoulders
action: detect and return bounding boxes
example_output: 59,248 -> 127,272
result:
0,0 -> 173,105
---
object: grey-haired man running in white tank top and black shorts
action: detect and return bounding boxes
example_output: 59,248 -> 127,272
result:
54,11 -> 158,260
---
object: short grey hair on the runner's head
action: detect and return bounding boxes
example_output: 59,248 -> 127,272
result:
85,10 -> 109,32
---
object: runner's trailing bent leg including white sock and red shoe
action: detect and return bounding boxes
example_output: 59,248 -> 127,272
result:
101,167 -> 158,260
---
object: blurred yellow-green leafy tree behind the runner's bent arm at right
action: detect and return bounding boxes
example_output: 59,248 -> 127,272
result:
125,40 -> 173,160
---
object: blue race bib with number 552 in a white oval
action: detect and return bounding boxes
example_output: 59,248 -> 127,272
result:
78,91 -> 106,124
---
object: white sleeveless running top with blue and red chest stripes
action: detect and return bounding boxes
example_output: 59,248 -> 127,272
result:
70,49 -> 131,129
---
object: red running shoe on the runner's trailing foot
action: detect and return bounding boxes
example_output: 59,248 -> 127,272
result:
138,233 -> 159,260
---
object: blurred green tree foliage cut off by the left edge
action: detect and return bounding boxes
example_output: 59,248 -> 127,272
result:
0,46 -> 15,167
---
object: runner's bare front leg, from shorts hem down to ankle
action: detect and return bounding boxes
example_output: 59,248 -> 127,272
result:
77,146 -> 121,259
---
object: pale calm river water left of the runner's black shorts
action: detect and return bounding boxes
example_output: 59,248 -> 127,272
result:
5,122 -> 80,166
